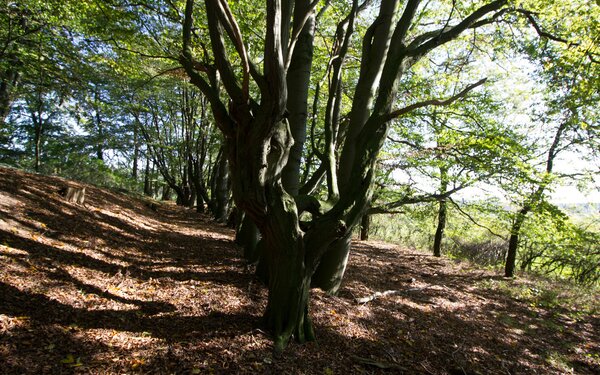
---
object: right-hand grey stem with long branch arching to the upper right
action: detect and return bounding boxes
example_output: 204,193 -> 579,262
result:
313,0 -> 506,293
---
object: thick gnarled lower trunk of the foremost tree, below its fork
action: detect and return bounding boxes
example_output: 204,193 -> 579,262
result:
228,118 -> 322,351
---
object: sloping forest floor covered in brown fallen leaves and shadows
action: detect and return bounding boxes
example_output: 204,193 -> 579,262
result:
0,168 -> 600,375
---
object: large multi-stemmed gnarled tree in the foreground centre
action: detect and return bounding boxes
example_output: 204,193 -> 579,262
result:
180,0 -> 507,349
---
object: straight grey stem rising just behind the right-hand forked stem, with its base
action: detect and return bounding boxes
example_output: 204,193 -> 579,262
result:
313,0 -> 410,294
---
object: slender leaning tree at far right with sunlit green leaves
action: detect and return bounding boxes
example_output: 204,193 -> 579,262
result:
504,2 -> 600,277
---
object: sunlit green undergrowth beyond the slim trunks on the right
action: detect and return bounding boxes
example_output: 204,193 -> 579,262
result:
371,202 -> 600,288
